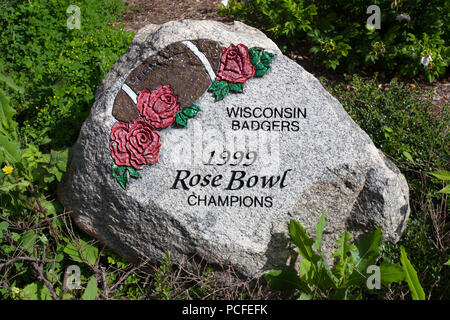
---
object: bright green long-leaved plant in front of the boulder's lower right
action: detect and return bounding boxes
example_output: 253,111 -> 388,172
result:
265,213 -> 423,300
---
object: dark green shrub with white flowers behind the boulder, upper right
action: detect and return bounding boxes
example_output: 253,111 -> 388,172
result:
221,0 -> 450,82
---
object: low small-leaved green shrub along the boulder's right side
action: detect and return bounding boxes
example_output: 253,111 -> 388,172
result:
330,76 -> 450,298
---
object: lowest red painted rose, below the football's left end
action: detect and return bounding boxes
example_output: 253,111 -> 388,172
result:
110,118 -> 161,169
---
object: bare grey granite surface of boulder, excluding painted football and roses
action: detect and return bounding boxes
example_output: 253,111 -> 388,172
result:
58,20 -> 409,277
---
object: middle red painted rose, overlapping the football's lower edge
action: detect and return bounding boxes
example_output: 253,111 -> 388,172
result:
136,85 -> 180,128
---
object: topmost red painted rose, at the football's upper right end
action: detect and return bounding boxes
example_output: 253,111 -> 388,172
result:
216,44 -> 255,83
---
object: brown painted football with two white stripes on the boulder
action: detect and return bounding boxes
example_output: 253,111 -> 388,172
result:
112,40 -> 221,122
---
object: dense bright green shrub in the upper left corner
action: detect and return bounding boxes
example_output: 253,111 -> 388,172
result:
0,0 -> 132,147
